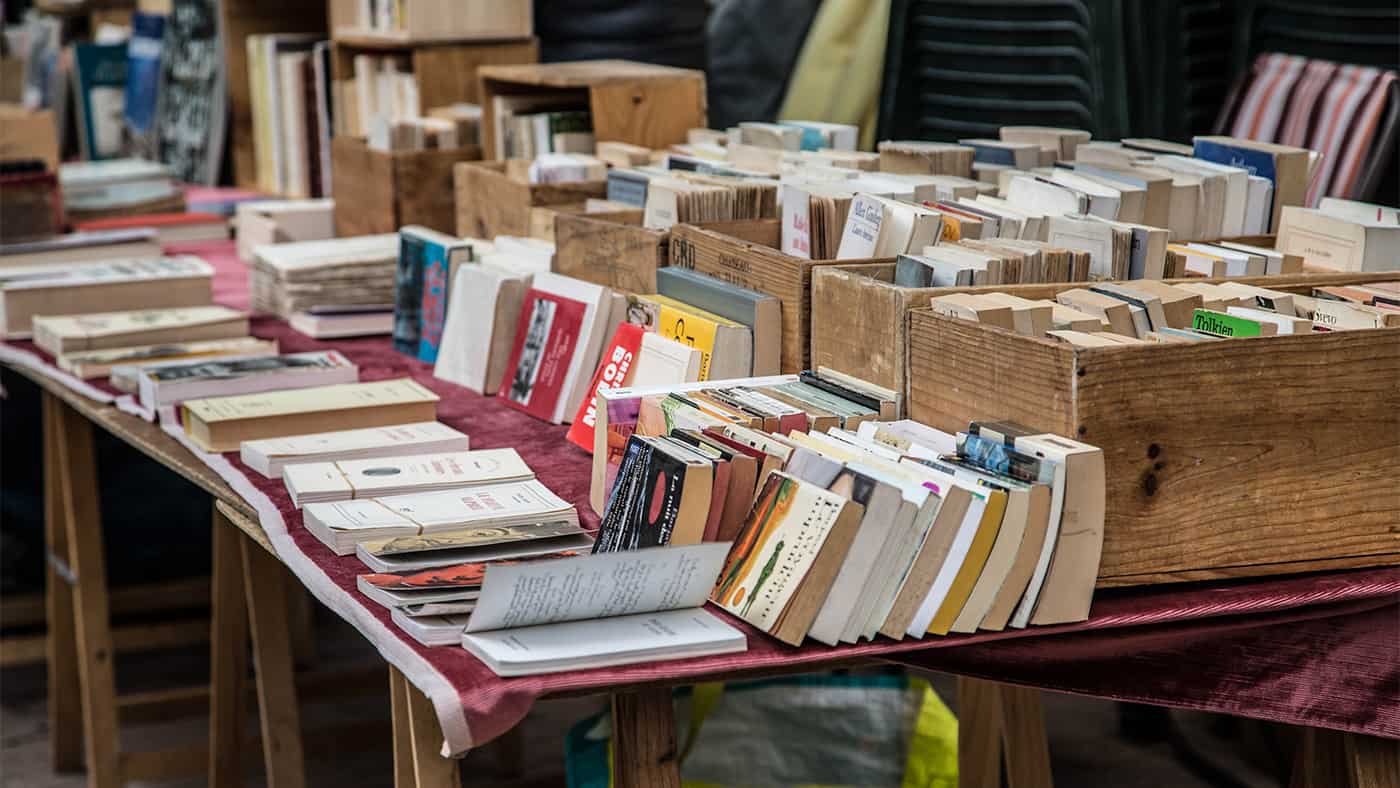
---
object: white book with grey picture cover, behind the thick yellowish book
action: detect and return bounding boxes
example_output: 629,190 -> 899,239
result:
140,350 -> 360,411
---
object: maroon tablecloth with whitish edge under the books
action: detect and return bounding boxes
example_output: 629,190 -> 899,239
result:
5,237 -> 1400,752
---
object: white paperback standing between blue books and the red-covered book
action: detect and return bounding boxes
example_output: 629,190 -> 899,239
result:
433,263 -> 533,396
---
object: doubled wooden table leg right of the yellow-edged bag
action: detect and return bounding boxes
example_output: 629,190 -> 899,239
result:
958,676 -> 1053,788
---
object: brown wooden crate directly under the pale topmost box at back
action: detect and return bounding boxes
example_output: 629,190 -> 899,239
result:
330,36 -> 539,113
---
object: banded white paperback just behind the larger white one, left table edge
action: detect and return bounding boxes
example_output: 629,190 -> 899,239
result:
281,449 -> 535,508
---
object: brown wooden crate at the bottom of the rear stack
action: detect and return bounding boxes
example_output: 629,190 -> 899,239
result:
330,137 -> 482,235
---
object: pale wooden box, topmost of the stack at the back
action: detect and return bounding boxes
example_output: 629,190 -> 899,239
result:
329,0 -> 535,42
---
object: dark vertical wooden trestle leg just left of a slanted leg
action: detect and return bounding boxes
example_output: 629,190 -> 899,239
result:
209,507 -> 248,788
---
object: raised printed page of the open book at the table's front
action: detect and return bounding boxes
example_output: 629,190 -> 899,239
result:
466,542 -> 729,633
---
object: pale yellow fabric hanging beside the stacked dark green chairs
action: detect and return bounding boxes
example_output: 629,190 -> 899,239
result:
778,0 -> 889,150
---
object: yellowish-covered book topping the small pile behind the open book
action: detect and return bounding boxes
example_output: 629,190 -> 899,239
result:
355,520 -> 594,572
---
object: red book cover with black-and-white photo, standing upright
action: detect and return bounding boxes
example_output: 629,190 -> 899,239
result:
497,290 -> 588,424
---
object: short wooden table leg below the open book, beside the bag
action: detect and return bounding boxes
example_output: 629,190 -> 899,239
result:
612,687 -> 680,788
